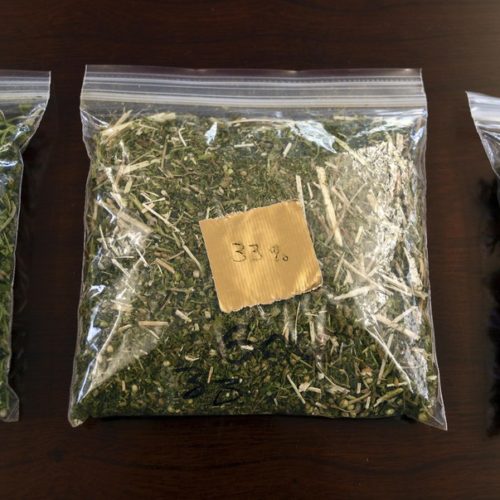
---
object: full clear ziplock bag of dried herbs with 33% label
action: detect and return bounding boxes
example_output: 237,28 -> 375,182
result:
69,66 -> 446,429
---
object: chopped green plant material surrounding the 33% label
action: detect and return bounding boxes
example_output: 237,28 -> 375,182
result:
70,111 -> 442,425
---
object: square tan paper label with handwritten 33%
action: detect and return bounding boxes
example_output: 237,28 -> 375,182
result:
200,201 -> 322,312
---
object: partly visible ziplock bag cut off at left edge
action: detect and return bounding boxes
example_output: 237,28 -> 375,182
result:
0,70 -> 50,422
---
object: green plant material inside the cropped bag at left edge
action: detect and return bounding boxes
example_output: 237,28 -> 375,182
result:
0,106 -> 41,420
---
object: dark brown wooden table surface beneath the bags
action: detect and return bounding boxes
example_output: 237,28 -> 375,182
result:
0,0 -> 500,499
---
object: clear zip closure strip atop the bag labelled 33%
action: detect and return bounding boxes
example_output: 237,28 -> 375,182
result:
81,66 -> 426,107
